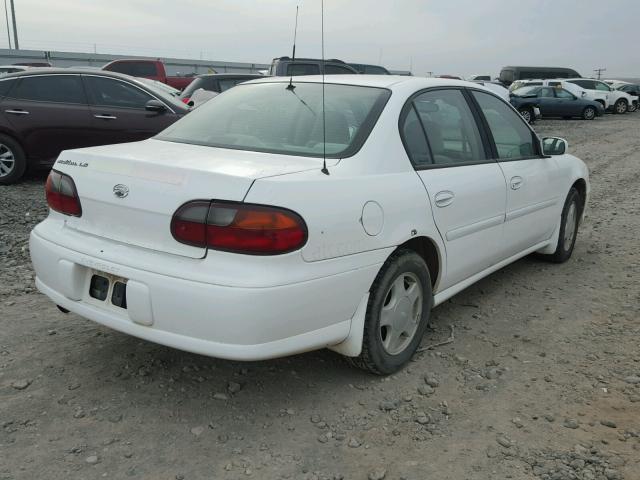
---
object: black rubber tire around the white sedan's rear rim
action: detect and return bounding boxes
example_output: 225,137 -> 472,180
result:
349,249 -> 433,375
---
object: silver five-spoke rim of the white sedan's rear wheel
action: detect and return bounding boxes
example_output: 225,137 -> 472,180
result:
379,272 -> 423,355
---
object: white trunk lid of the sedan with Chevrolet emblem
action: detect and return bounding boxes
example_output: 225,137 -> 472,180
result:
53,139 -> 320,258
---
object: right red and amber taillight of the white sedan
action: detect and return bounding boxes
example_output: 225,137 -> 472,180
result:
171,200 -> 307,255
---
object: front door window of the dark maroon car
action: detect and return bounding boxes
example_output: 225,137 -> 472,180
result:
84,76 -> 153,109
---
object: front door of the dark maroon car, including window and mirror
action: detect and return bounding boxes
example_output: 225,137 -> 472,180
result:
83,75 -> 177,145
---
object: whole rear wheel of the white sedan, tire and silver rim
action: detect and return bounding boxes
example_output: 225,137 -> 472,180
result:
349,249 -> 433,375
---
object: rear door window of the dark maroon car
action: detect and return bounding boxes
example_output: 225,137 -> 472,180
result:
11,75 -> 87,104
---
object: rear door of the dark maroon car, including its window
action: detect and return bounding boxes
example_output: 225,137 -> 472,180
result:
2,74 -> 94,161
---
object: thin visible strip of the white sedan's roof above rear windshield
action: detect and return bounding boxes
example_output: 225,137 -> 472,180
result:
245,74 -> 478,90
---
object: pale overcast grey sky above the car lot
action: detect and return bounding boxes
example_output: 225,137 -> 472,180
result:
5,0 -> 640,78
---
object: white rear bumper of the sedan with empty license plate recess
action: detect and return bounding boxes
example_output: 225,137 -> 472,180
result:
30,231 -> 381,360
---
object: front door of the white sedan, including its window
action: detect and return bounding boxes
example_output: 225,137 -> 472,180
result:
472,90 -> 564,258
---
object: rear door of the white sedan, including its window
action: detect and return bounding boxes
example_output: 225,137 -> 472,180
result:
400,89 -> 506,289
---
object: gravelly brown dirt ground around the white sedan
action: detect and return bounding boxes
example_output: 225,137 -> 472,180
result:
0,114 -> 640,480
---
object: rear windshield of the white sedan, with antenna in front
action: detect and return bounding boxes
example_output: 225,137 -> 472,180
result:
156,82 -> 391,158
